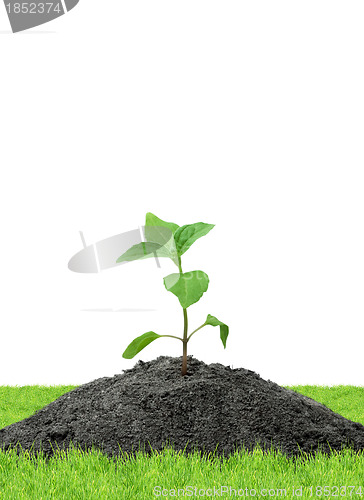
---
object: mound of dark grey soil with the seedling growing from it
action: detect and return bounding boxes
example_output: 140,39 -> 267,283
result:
0,356 -> 364,457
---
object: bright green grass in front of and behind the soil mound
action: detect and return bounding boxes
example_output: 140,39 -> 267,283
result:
0,386 -> 364,500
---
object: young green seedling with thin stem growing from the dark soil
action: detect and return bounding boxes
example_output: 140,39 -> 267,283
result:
116,212 -> 229,375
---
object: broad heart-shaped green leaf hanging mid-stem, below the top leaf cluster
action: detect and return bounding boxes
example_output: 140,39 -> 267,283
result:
164,271 -> 209,309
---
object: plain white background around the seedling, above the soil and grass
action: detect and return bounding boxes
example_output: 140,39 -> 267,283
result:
0,0 -> 364,385
